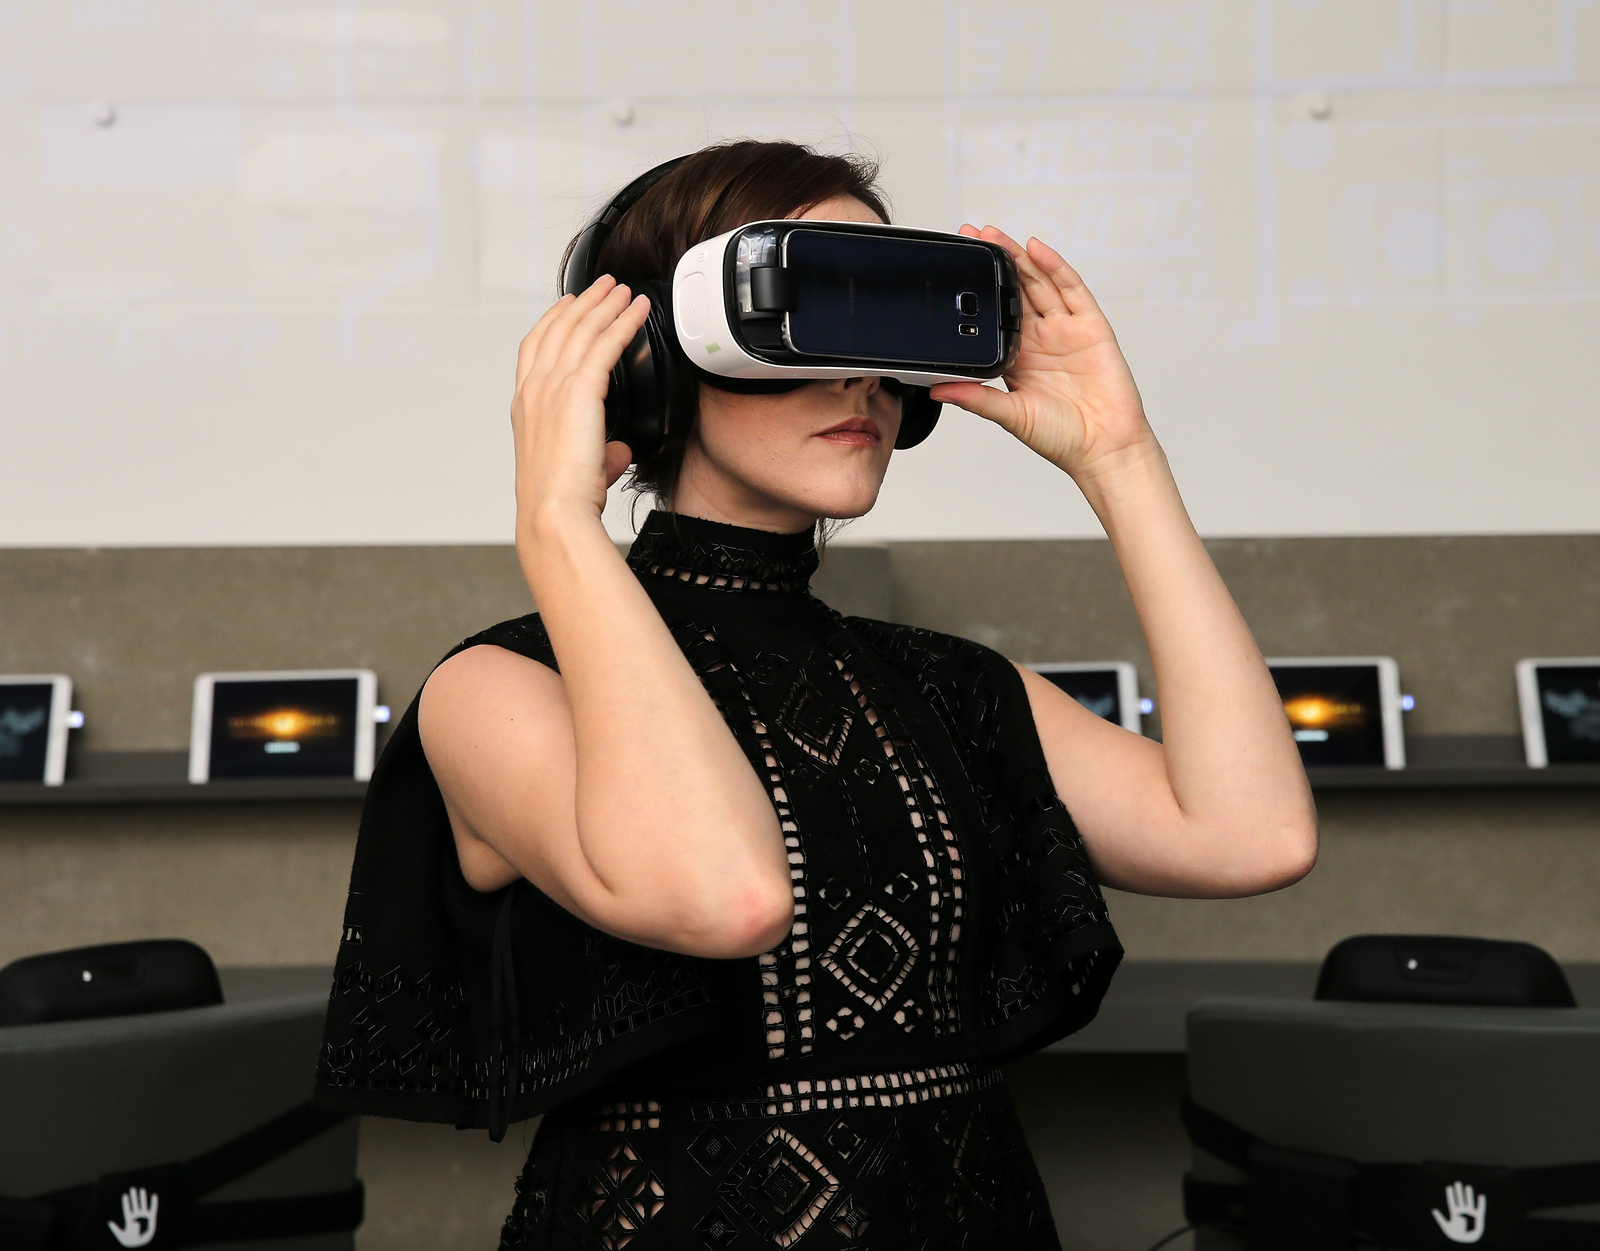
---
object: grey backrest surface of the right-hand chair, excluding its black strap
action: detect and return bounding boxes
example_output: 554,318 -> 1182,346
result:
1189,998 -> 1600,1248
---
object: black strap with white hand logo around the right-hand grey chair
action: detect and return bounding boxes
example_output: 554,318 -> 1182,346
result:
1184,1101 -> 1600,1251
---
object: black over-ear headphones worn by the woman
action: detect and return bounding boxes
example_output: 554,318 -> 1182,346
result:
562,157 -> 942,462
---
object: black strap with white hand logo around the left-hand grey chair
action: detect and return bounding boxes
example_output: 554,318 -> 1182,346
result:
0,1104 -> 365,1251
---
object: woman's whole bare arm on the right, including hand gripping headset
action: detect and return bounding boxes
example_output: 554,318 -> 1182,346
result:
934,226 -> 1317,896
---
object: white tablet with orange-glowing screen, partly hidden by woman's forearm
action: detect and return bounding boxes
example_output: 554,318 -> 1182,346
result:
1267,656 -> 1405,769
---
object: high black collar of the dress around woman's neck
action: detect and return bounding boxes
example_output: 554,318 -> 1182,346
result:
627,509 -> 818,592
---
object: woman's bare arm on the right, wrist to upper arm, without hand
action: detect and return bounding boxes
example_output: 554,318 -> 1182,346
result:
1022,446 -> 1317,897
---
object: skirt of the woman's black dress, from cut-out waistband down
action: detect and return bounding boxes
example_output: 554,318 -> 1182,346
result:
501,1065 -> 1059,1251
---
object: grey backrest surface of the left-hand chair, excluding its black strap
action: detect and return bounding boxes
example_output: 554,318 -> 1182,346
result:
0,993 -> 357,1251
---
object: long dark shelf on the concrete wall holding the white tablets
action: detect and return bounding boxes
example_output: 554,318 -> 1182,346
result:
0,734 -> 1600,806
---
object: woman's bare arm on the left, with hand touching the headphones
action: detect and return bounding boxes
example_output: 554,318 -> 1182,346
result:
419,278 -> 794,957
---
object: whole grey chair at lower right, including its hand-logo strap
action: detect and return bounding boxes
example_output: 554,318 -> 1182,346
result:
1184,998 -> 1600,1251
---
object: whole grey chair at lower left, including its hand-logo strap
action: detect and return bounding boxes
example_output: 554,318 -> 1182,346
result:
0,993 -> 362,1251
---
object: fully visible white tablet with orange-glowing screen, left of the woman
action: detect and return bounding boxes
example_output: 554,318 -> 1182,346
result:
189,669 -> 378,782
